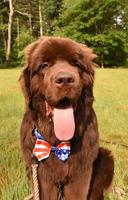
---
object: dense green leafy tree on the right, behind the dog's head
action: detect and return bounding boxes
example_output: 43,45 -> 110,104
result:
54,0 -> 128,66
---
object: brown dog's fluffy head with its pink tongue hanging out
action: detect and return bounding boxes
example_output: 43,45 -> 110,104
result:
20,37 -> 96,140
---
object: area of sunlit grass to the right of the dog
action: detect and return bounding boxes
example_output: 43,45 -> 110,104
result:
94,69 -> 128,200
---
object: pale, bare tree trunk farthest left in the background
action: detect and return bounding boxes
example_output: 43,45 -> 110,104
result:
6,0 -> 13,62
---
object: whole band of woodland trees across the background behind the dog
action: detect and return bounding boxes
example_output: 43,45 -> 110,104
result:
0,0 -> 128,67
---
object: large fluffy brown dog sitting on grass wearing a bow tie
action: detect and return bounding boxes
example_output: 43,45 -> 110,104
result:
20,37 -> 114,200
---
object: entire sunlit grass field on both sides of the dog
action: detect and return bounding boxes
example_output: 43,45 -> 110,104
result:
0,69 -> 128,200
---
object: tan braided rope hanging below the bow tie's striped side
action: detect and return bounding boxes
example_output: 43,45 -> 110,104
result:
32,164 -> 40,200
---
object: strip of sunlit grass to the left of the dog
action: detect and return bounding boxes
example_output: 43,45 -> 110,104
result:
0,69 -> 28,200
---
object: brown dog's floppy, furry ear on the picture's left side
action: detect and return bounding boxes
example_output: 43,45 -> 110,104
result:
19,40 -> 39,107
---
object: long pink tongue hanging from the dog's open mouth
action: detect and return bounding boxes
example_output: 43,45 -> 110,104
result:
53,107 -> 75,141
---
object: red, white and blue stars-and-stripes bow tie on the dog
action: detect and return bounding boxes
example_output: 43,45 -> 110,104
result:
33,129 -> 70,161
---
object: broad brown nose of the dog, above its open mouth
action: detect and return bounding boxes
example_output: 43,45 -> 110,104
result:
55,72 -> 75,87
